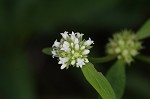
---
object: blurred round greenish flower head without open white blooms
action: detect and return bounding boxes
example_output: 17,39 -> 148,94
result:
106,30 -> 142,64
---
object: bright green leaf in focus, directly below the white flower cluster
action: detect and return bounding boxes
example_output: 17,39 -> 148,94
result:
82,63 -> 116,99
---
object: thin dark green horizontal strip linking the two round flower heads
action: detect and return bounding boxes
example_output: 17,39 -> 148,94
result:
89,55 -> 116,63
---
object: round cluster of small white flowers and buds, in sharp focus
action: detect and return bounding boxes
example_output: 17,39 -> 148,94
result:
52,31 -> 94,69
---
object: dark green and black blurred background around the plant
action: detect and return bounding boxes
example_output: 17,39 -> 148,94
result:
0,0 -> 150,99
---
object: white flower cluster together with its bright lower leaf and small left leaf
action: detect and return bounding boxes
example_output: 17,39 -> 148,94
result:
43,31 -> 116,99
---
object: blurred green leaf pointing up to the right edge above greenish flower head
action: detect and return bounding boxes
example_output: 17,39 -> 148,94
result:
137,19 -> 150,39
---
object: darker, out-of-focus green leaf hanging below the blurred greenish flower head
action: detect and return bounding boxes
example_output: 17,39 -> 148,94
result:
106,60 -> 126,99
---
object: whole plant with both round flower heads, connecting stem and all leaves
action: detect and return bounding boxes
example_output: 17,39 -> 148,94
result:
43,20 -> 150,99
